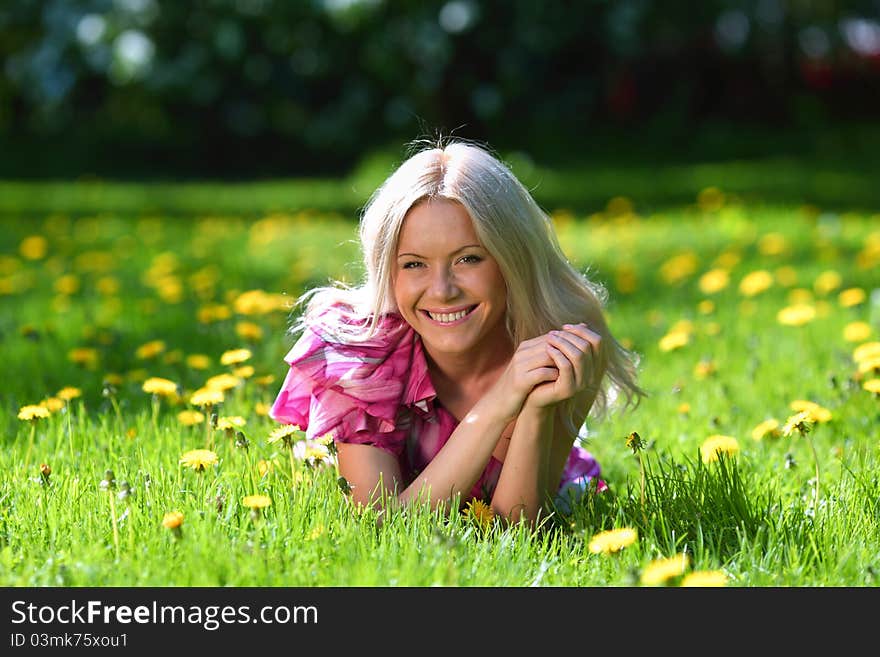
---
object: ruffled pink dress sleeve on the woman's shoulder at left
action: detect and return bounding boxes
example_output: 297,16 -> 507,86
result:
269,312 -> 414,456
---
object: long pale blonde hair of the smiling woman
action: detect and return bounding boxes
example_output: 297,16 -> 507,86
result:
294,140 -> 644,430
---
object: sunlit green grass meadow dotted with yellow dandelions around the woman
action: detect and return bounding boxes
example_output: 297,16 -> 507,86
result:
0,156 -> 880,587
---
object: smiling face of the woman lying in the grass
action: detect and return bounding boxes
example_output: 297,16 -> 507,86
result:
393,199 -> 509,356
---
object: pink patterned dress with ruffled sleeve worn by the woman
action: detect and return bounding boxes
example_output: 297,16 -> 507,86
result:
269,308 -> 604,502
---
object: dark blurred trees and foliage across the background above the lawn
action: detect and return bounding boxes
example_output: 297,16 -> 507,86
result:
0,0 -> 880,176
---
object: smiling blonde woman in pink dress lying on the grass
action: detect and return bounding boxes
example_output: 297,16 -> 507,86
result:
270,141 -> 642,524
